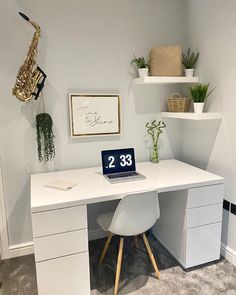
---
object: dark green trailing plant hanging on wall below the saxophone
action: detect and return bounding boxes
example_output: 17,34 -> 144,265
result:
36,113 -> 55,163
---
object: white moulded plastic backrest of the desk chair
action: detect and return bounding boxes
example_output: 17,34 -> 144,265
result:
108,190 -> 160,236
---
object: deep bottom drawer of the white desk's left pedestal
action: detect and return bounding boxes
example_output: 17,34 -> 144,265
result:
36,252 -> 90,295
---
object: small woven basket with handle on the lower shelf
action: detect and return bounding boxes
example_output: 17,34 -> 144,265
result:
168,92 -> 191,112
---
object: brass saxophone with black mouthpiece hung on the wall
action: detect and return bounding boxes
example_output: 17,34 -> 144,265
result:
12,12 -> 47,102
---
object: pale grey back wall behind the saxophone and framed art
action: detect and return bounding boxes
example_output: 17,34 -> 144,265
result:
0,0 -> 186,249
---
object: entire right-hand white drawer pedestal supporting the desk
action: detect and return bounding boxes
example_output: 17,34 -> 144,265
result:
152,184 -> 223,268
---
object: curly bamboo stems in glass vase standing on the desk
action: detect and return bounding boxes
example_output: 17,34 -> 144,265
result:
146,120 -> 166,163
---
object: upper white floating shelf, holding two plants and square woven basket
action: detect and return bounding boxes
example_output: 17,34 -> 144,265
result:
133,76 -> 199,85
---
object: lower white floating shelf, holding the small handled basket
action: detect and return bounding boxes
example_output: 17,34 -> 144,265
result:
161,112 -> 223,121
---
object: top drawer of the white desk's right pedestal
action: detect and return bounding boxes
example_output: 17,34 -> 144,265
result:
187,184 -> 224,208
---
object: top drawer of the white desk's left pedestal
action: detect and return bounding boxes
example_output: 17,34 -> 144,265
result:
32,206 -> 87,238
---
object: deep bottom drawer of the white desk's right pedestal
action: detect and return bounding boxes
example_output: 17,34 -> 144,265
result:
185,222 -> 221,268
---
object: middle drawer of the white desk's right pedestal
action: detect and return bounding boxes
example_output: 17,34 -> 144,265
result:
186,203 -> 222,228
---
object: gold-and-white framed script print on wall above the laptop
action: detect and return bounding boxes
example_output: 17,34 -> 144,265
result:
69,93 -> 121,137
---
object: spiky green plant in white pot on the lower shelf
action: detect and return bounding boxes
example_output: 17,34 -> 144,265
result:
188,83 -> 214,114
